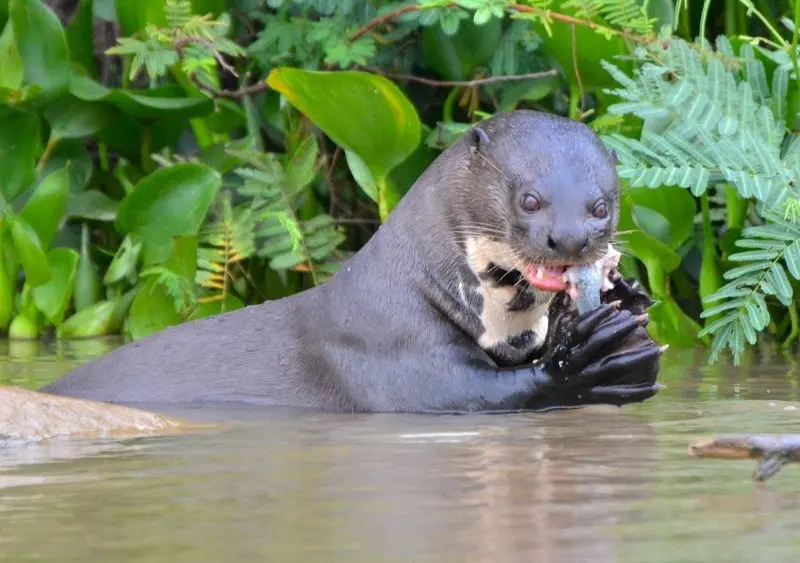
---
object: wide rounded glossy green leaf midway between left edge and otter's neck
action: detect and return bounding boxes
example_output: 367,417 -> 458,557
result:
114,164 -> 222,266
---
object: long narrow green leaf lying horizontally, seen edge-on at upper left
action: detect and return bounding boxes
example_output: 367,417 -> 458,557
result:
69,76 -> 214,119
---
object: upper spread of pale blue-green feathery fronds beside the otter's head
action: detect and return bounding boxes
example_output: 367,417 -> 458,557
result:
603,39 -> 800,208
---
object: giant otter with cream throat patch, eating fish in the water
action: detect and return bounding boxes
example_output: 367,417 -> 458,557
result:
42,111 -> 661,412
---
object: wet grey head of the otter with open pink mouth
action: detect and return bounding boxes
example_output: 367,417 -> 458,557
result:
458,110 -> 620,292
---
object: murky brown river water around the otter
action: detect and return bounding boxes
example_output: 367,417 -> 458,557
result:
0,341 -> 800,563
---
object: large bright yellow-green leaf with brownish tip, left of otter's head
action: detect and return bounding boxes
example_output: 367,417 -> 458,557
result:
267,67 -> 420,184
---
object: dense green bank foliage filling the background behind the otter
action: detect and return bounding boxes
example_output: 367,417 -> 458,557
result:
0,0 -> 800,366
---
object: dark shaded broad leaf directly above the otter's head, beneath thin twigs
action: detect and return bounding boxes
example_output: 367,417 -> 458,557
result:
422,18 -> 503,80
